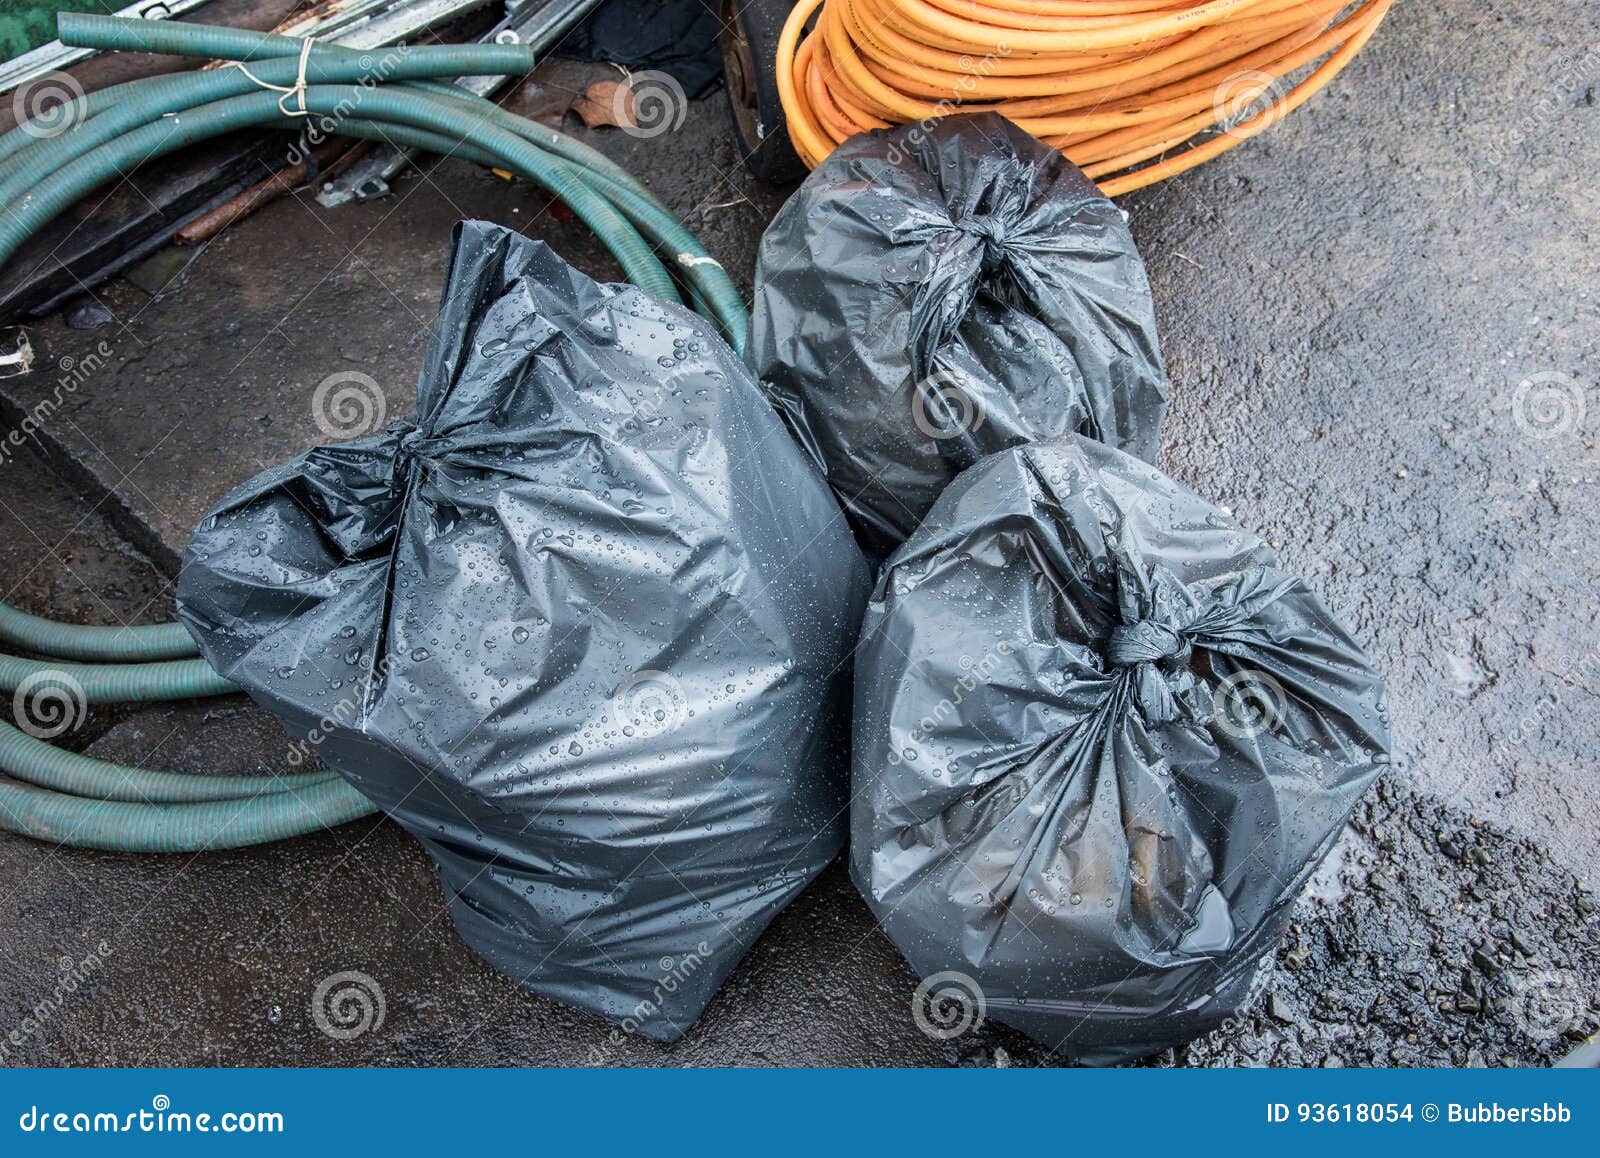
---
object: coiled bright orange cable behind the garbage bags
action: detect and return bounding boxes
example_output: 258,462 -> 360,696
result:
778,0 -> 1394,197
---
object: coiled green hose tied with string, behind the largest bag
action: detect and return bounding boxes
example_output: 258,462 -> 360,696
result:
0,13 -> 747,853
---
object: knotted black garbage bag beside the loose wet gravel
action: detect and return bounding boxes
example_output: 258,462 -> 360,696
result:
851,435 -> 1389,1062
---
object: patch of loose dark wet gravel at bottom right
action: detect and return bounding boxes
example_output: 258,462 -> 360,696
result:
947,774 -> 1600,1067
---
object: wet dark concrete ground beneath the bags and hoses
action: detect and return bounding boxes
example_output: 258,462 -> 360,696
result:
0,0 -> 1600,1065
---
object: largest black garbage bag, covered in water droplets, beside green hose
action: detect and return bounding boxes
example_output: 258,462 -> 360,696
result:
178,222 -> 867,1040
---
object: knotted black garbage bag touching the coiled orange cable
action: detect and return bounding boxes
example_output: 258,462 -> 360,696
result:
746,114 -> 1166,555
